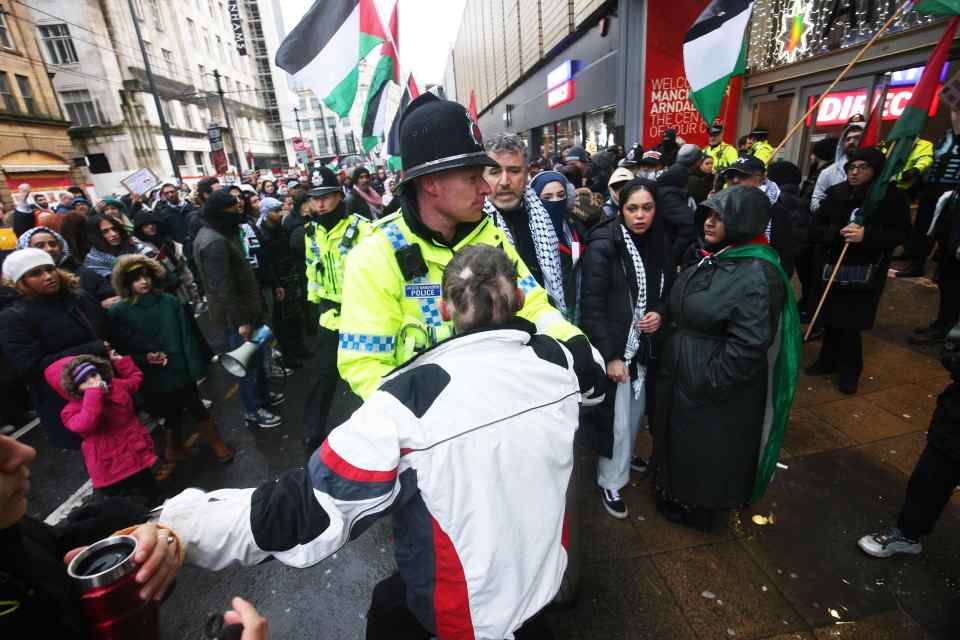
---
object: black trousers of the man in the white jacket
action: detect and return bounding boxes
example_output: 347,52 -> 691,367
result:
366,573 -> 554,640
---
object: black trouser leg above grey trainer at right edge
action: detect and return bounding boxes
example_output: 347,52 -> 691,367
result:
897,443 -> 960,540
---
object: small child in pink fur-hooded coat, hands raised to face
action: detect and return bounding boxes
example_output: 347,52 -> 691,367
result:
44,351 -> 158,506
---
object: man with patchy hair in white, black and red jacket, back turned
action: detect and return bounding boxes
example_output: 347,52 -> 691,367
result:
160,245 -> 605,640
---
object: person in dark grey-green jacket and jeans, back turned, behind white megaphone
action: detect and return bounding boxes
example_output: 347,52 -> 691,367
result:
193,190 -> 285,429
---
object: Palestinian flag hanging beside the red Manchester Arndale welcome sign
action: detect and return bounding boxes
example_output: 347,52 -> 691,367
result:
683,0 -> 753,122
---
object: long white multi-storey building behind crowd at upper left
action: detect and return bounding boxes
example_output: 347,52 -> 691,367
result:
27,0 -> 286,194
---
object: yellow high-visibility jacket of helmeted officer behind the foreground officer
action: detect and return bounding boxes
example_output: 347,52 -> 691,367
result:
304,214 -> 373,331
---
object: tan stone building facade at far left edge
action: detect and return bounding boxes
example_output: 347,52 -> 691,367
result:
0,0 -> 84,211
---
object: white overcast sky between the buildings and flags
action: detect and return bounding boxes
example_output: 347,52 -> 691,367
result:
282,0 -> 466,87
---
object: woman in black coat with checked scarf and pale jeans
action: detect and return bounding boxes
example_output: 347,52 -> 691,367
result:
581,178 -> 674,518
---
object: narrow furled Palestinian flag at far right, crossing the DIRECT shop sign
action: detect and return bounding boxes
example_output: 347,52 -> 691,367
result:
857,16 -> 960,224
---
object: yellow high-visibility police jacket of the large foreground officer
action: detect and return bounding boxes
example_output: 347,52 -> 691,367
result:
337,209 -> 582,399
